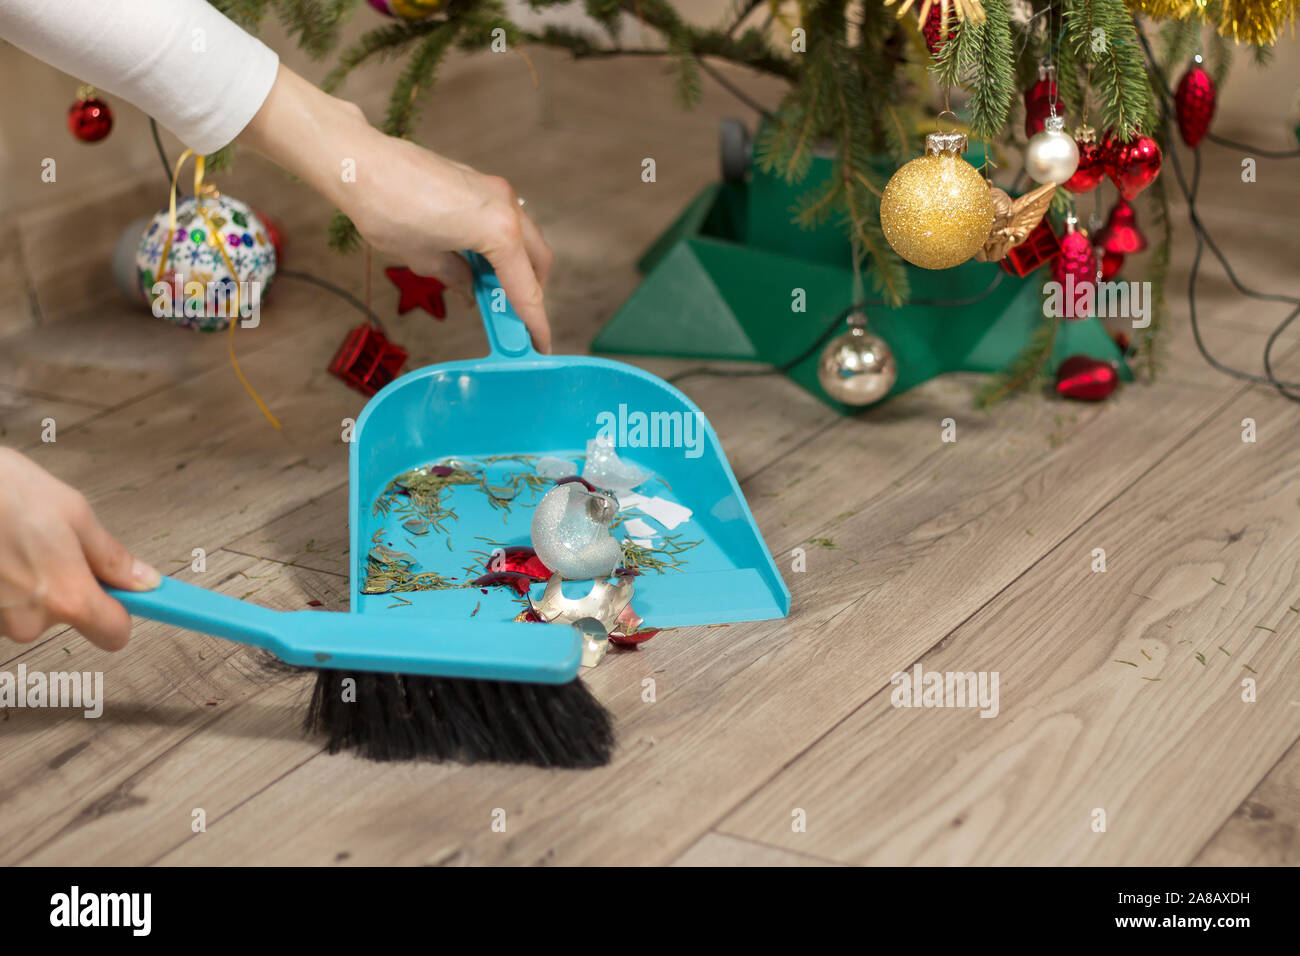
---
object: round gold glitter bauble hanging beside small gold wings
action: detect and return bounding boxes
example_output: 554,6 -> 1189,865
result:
880,133 -> 993,269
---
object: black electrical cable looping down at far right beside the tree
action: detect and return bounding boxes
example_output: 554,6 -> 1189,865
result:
1138,27 -> 1300,403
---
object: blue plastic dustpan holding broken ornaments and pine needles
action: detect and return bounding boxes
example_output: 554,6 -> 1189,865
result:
348,254 -> 790,628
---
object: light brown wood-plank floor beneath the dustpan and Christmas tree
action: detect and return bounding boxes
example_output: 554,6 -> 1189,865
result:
0,46 -> 1300,865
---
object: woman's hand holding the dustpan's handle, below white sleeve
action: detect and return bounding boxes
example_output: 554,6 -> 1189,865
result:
237,65 -> 551,352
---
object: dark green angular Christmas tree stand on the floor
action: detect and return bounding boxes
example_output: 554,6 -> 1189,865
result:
592,132 -> 1132,415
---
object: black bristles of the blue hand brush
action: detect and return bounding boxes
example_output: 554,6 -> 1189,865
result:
307,670 -> 614,767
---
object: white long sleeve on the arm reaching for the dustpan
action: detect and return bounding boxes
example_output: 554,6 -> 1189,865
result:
0,0 -> 280,155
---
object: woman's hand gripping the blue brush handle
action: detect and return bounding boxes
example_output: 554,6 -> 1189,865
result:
0,449 -> 160,650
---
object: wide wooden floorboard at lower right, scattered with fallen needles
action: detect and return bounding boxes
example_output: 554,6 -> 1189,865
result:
720,374 -> 1300,865
